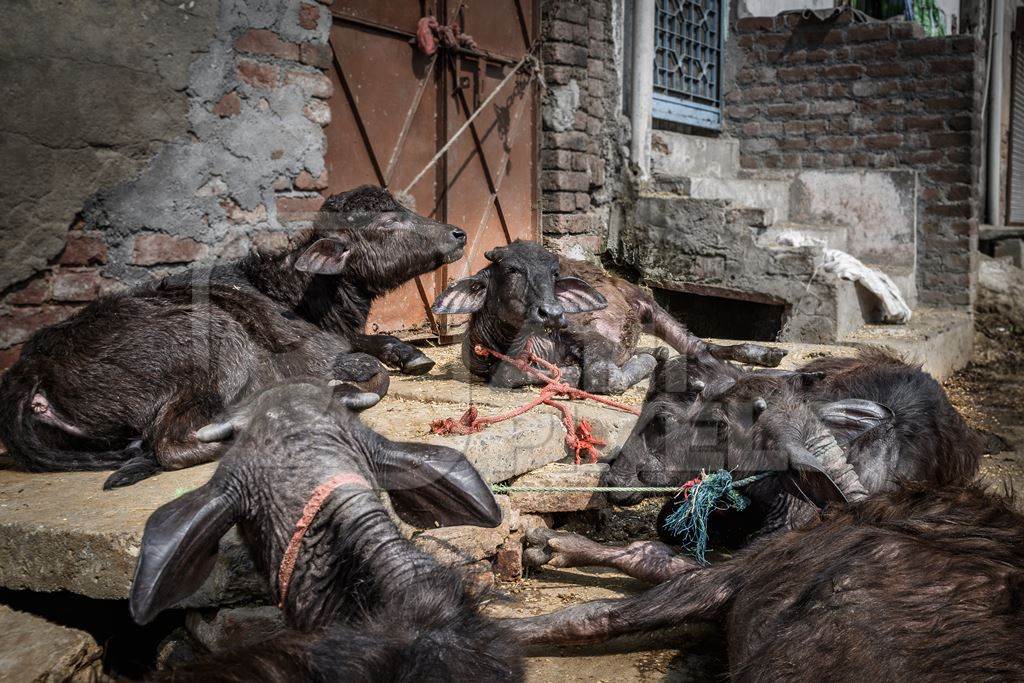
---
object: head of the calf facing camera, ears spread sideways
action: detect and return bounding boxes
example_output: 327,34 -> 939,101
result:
433,241 -> 608,331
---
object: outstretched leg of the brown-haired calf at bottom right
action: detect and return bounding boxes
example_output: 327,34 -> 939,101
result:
502,563 -> 739,645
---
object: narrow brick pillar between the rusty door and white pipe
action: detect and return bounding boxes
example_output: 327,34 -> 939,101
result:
541,0 -> 623,256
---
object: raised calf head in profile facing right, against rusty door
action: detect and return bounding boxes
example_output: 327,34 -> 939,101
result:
295,185 -> 466,293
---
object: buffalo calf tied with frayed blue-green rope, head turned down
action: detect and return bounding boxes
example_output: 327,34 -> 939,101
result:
526,350 -> 981,583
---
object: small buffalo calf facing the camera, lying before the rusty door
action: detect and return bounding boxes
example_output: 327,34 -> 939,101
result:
433,241 -> 785,393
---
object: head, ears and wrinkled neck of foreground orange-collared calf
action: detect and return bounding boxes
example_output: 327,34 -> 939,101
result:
130,380 -> 501,628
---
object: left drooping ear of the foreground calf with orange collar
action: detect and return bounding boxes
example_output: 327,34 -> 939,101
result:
128,483 -> 234,624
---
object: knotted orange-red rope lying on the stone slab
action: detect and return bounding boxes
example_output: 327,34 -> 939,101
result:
430,340 -> 640,465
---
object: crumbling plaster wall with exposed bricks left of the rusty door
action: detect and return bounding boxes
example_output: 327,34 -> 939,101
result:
0,0 -> 332,367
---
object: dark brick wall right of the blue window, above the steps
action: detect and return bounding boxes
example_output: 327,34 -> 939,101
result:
725,17 -> 984,305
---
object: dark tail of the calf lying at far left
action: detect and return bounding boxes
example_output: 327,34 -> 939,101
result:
0,369 -> 130,472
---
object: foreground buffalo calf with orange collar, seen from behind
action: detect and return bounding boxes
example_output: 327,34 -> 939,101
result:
130,381 -> 521,682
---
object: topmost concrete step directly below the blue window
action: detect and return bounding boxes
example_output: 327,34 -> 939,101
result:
650,130 -> 739,178
